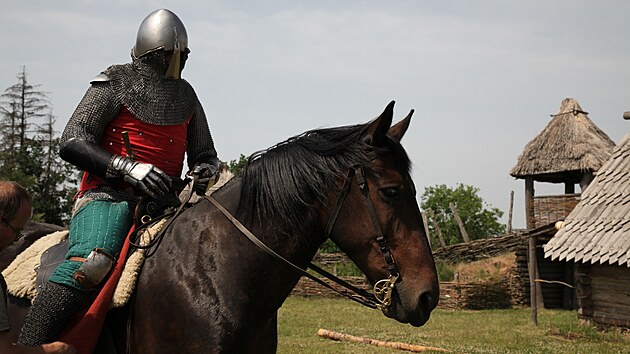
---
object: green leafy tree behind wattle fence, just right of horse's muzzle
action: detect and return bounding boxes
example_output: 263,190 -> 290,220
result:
420,184 -> 505,245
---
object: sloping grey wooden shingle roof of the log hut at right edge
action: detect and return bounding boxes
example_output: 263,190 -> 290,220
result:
544,133 -> 630,267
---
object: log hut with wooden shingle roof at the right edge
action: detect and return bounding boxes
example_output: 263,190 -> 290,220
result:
544,133 -> 630,328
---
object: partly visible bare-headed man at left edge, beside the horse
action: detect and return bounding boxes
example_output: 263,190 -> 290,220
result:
0,181 -> 76,354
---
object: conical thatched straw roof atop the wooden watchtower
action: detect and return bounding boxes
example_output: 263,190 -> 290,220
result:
510,98 -> 615,183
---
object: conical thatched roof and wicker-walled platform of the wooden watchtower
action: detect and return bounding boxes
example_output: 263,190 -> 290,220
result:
510,98 -> 615,229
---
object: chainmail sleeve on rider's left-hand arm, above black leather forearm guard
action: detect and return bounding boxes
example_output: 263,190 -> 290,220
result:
61,82 -> 121,144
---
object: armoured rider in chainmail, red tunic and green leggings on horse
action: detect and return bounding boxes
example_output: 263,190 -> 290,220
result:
18,9 -> 219,345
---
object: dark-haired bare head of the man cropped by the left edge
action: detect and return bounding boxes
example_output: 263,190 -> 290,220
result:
0,181 -> 32,249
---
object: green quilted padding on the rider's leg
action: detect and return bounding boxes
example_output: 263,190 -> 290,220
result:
49,200 -> 133,291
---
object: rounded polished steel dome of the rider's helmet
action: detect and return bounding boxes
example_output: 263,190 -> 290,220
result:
131,9 -> 188,59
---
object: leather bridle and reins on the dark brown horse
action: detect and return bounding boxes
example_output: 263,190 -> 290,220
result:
205,167 -> 400,311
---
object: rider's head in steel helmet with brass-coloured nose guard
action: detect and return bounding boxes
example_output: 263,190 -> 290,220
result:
131,9 -> 190,79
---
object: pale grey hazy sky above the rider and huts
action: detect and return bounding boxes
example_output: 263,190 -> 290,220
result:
0,0 -> 630,228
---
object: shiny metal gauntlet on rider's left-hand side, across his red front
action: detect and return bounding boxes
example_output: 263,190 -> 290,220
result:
107,155 -> 171,198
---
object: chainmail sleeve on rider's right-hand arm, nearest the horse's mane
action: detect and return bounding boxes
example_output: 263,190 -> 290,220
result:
187,96 -> 219,169
